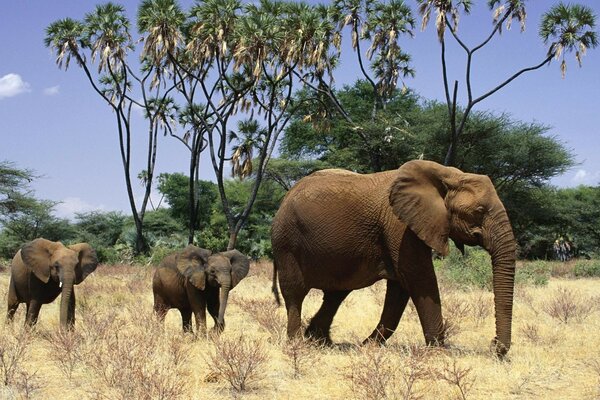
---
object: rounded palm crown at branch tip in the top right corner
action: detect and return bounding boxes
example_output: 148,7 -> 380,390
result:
540,2 -> 598,78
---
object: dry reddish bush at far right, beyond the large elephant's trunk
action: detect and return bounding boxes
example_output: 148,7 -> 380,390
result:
542,287 -> 593,324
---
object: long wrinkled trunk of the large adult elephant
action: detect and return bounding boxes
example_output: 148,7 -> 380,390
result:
485,209 -> 516,356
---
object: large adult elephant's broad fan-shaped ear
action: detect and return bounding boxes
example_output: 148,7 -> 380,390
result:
389,160 -> 460,255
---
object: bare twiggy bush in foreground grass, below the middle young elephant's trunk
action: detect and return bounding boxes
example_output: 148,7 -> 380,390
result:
207,335 -> 269,393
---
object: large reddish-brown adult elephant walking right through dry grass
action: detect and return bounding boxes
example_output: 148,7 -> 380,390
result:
271,160 -> 516,355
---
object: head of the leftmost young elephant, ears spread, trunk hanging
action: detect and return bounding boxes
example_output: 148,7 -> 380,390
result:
21,238 -> 98,326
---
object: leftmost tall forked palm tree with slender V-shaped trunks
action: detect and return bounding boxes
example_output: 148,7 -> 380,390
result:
44,2 -> 183,253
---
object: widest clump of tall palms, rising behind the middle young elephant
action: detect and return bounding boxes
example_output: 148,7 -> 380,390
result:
138,0 -> 346,248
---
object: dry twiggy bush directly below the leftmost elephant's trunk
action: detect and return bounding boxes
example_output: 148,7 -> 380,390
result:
42,329 -> 84,379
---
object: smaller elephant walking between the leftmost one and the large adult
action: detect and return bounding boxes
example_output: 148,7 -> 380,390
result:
152,245 -> 250,335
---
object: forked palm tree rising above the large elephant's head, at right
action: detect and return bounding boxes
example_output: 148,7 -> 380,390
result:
417,0 -> 598,165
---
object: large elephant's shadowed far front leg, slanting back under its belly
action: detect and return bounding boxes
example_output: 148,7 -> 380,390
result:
363,280 -> 410,344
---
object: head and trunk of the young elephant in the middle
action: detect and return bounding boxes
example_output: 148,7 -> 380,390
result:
207,250 -> 250,326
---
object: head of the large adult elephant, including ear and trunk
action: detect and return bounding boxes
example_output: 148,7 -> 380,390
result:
389,160 -> 516,355
